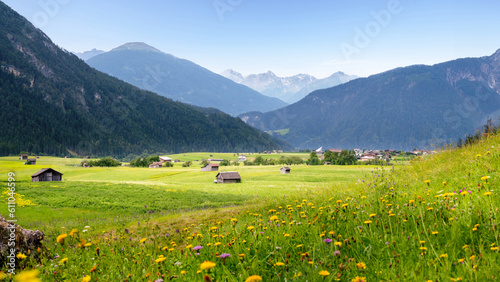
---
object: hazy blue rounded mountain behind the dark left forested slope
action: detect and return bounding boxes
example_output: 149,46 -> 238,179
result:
87,42 -> 287,115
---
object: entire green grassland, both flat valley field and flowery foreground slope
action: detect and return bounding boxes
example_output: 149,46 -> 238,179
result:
2,136 -> 500,282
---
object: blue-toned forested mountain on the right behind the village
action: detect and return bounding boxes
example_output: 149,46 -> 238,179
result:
240,50 -> 500,150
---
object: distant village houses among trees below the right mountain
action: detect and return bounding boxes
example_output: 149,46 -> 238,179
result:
316,147 -> 436,162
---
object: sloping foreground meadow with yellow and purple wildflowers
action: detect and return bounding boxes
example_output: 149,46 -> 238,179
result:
0,139 -> 500,281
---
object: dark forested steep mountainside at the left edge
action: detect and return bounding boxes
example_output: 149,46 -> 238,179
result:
0,2 -> 290,157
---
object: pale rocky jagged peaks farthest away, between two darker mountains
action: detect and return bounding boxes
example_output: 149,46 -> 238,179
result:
221,69 -> 357,103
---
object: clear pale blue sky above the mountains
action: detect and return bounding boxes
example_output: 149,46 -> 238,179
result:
2,0 -> 500,78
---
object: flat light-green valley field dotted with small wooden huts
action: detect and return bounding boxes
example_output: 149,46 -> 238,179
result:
0,153 -> 368,230
